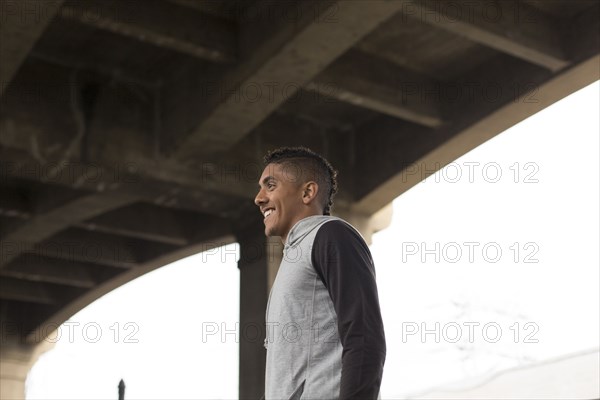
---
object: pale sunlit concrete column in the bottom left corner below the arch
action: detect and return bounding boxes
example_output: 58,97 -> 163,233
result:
0,335 -> 54,400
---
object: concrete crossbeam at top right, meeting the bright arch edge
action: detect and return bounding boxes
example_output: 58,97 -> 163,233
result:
402,0 -> 569,71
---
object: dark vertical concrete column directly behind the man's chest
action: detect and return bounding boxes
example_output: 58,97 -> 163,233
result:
236,219 -> 283,399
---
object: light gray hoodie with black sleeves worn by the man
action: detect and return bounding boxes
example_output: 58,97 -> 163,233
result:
265,216 -> 385,400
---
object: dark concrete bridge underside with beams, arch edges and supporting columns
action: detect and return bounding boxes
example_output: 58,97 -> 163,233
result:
0,0 -> 600,398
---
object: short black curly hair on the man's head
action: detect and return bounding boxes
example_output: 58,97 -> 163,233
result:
264,146 -> 337,215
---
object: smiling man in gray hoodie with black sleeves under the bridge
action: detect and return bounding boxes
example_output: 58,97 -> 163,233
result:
255,147 -> 386,400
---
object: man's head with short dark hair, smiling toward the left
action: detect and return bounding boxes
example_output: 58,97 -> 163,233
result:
254,147 -> 337,240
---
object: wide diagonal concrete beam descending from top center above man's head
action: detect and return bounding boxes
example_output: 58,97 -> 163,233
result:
174,0 -> 404,159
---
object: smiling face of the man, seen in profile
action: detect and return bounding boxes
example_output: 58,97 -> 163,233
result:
254,164 -> 304,240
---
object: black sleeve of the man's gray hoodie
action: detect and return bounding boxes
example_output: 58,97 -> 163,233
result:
311,221 -> 386,400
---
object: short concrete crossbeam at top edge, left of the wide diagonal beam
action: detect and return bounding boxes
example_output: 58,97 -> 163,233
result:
59,0 -> 236,63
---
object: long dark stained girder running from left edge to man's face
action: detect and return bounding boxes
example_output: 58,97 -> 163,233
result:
0,146 -> 255,217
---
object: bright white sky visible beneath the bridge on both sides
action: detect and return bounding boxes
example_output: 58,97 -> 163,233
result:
27,82 -> 600,400
